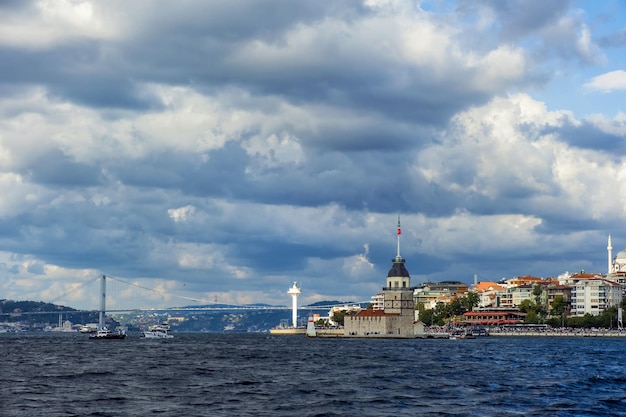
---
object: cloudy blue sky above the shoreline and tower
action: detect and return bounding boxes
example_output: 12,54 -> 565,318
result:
0,0 -> 626,309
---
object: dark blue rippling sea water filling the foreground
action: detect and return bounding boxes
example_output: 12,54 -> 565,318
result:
0,334 -> 626,417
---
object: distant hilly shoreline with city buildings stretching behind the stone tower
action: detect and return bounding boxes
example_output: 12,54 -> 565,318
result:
0,236 -> 626,333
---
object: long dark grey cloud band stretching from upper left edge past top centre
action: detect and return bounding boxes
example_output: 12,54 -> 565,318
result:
0,1 -> 520,125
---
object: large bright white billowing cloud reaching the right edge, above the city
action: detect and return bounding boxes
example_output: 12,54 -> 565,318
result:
415,95 -> 626,226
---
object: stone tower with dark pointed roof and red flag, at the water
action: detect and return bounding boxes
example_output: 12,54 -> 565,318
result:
344,217 -> 415,337
